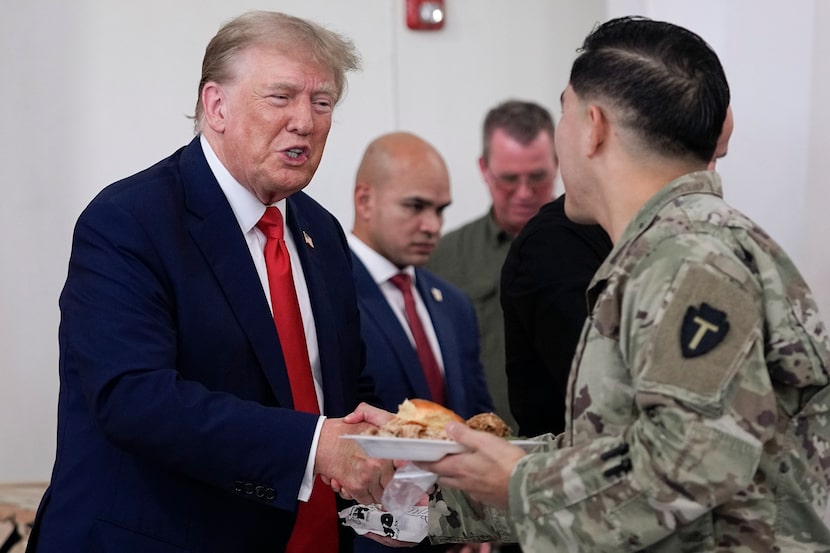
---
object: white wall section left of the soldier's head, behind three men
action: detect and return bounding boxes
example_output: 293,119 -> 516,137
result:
0,0 -> 605,482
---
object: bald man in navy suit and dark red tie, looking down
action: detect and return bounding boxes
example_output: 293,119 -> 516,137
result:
348,132 -> 493,553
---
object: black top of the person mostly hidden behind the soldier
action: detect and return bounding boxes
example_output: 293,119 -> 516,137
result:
501,196 -> 612,436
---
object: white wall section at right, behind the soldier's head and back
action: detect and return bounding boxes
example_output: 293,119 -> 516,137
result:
608,0 -> 830,302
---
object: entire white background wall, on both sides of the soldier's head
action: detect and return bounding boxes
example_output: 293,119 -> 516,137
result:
0,0 -> 830,481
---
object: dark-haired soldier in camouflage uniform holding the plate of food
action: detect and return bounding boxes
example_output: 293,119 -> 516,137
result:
419,18 -> 830,553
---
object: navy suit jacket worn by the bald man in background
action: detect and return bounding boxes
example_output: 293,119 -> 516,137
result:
352,254 -> 493,553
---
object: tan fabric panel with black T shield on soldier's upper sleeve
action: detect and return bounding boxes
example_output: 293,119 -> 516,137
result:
641,264 -> 760,405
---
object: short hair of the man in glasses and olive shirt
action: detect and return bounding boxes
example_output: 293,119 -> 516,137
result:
481,100 -> 554,161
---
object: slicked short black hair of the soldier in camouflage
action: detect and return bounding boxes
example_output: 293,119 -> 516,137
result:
570,17 -> 729,162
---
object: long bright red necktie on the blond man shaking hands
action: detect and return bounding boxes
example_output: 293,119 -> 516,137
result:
257,207 -> 339,553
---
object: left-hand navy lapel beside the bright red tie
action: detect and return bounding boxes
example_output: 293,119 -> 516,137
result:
181,137 -> 294,408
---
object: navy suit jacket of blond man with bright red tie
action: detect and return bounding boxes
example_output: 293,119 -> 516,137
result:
30,138 -> 371,553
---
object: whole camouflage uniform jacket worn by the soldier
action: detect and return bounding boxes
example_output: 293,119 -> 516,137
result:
431,172 -> 830,553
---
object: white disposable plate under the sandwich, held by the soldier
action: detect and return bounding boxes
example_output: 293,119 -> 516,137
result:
340,434 -> 542,461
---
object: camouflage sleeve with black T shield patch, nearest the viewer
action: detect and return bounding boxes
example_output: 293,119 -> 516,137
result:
509,241 -> 776,552
